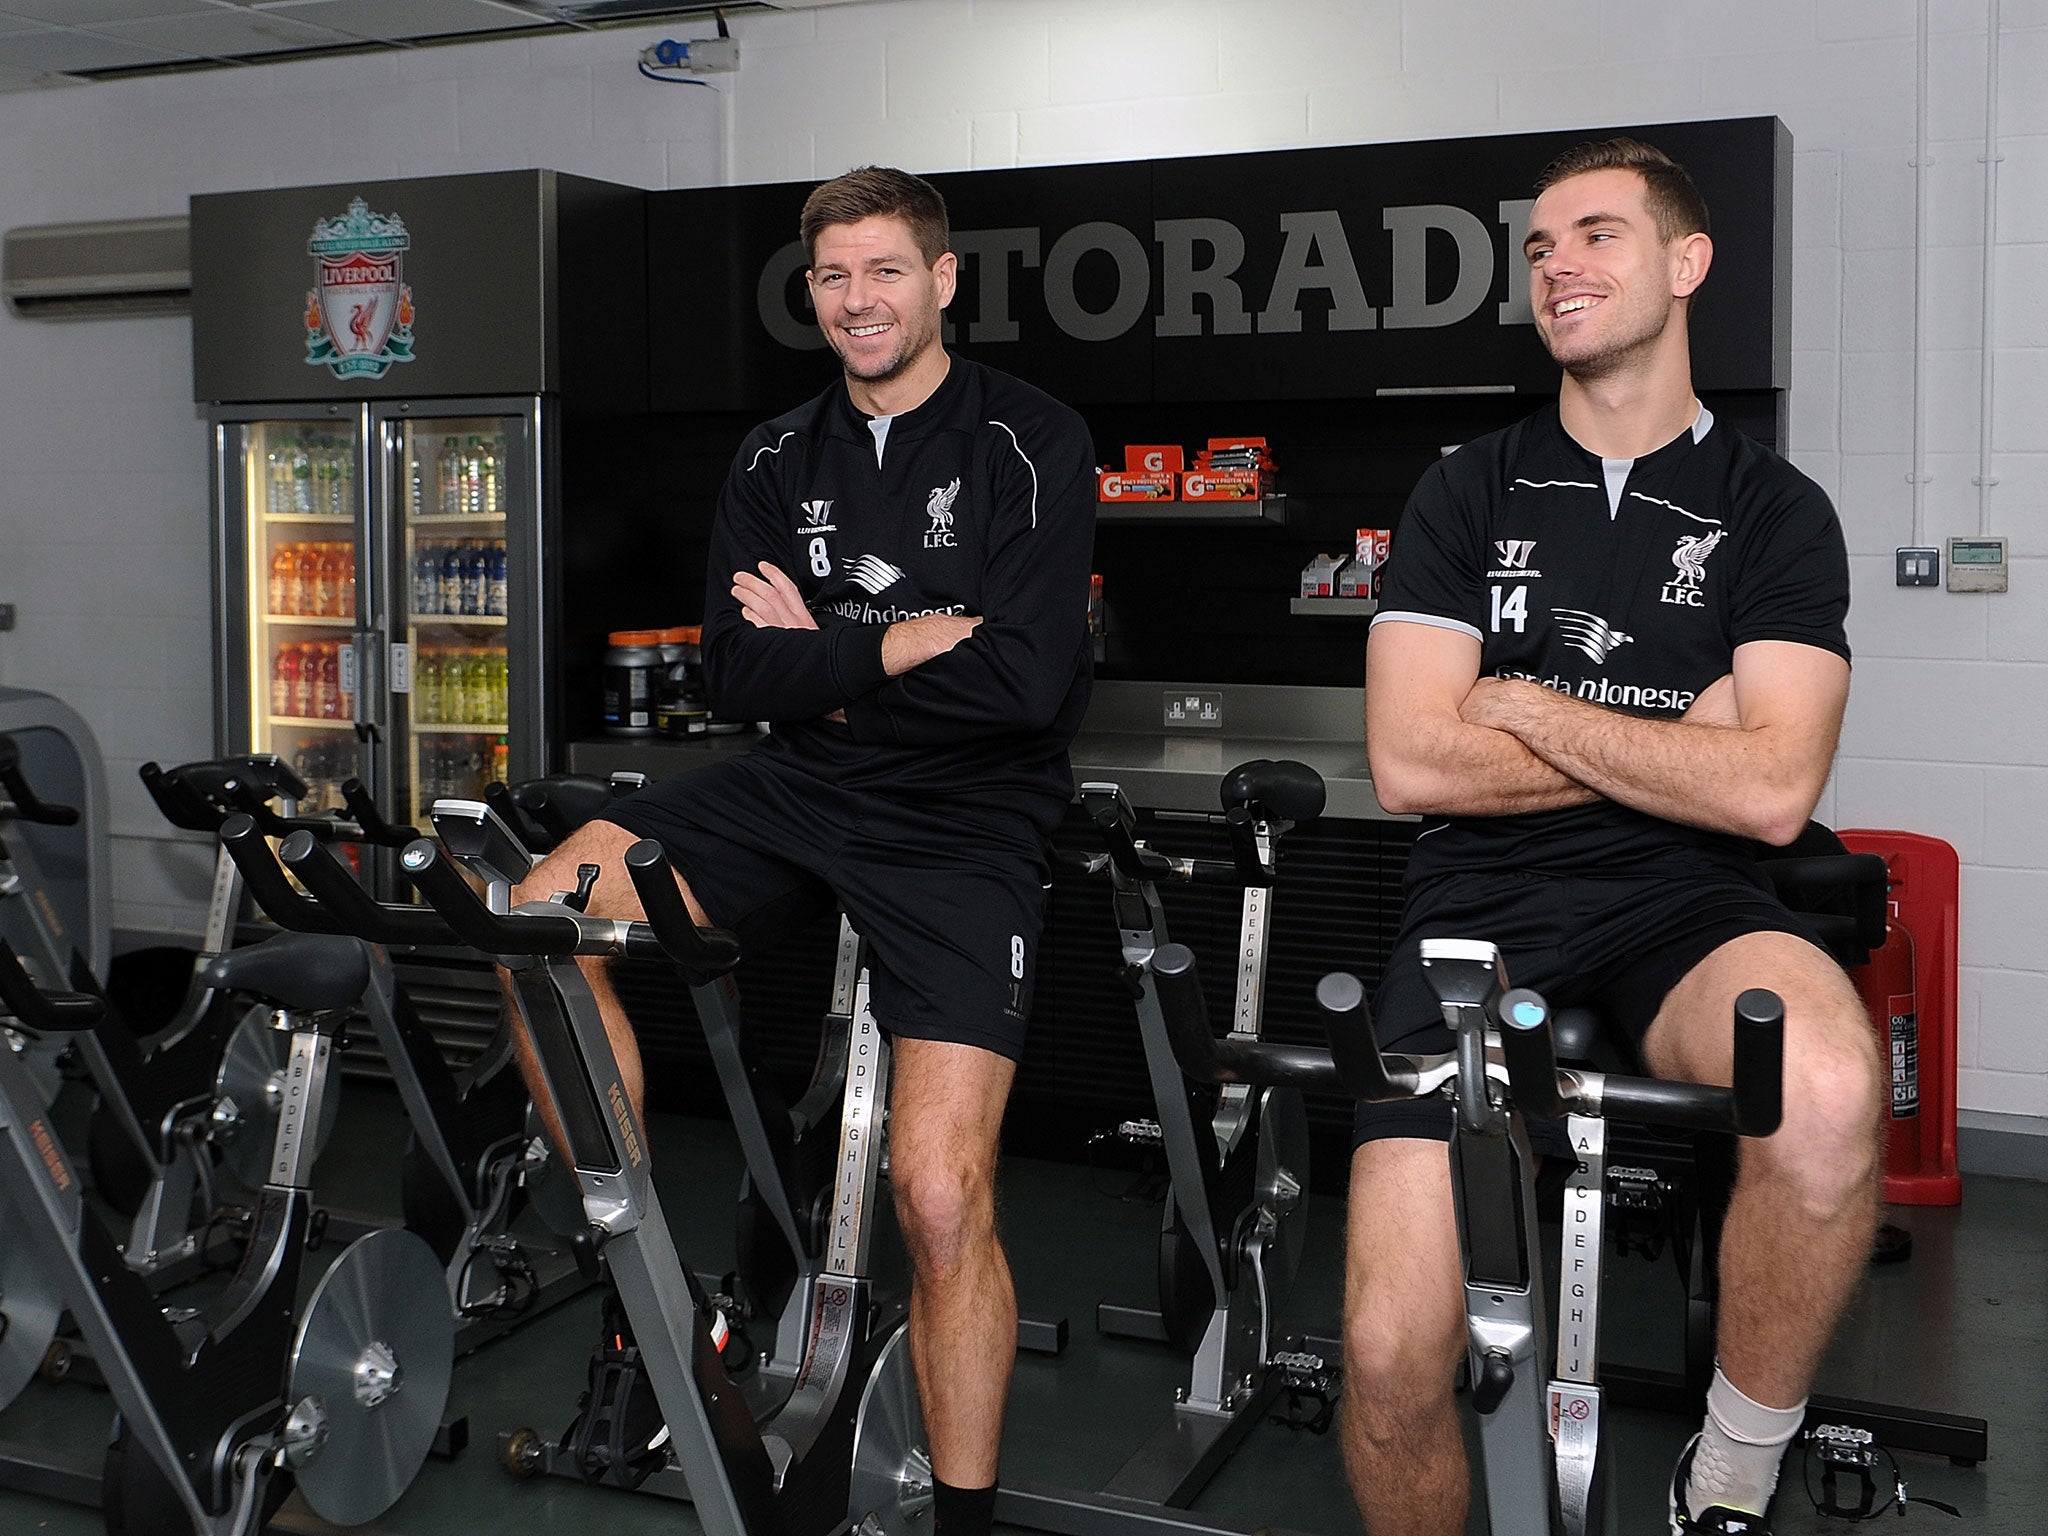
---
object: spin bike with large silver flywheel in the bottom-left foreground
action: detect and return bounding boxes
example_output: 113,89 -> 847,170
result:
0,921 -> 453,1536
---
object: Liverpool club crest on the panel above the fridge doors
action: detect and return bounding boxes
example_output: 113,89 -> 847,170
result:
305,197 -> 412,379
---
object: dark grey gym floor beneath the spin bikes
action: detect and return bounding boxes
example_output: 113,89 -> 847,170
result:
0,1081 -> 2048,1536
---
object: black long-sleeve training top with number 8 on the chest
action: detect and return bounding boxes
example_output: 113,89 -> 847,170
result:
705,356 -> 1096,827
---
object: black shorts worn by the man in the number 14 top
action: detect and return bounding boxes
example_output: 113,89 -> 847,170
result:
1352,852 -> 1819,1147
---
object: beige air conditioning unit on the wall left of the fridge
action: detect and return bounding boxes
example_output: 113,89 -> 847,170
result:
0,215 -> 193,319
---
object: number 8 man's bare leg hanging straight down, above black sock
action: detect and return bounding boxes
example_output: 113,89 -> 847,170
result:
889,1038 -> 1018,1489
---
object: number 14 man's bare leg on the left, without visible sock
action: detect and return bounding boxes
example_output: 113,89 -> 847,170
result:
1337,1139 -> 1470,1536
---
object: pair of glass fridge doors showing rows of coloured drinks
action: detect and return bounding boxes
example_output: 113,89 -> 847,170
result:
215,399 -> 549,891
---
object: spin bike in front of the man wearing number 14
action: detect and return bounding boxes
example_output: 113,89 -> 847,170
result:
1151,938 -> 1784,1536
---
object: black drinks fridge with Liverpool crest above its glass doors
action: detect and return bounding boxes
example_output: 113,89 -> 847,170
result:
190,170 -> 647,899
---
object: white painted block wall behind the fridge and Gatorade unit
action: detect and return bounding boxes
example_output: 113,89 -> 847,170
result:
0,0 -> 2048,1116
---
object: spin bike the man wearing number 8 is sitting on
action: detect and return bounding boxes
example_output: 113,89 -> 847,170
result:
279,801 -> 932,1536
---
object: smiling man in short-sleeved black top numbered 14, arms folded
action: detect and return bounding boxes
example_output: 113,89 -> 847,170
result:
1343,139 -> 1880,1536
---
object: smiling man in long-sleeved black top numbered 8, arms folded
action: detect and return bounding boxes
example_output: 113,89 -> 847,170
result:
520,166 -> 1096,1536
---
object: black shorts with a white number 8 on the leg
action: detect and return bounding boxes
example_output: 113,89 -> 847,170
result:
604,752 -> 1049,1061
